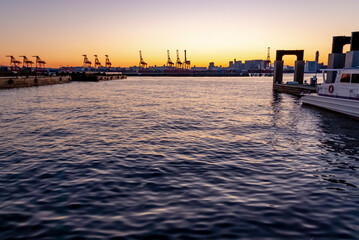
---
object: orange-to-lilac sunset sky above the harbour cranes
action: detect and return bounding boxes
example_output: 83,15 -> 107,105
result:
0,0 -> 359,67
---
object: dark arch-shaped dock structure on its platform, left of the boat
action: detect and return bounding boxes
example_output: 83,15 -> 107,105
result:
273,50 -> 316,96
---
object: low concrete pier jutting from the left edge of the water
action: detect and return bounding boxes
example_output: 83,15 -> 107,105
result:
0,76 -> 70,89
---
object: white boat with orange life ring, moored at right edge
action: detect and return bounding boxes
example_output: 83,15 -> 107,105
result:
302,68 -> 359,119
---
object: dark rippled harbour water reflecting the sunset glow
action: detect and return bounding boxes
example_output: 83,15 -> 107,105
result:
0,77 -> 359,240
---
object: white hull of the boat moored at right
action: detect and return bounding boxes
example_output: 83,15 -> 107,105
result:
302,94 -> 359,119
